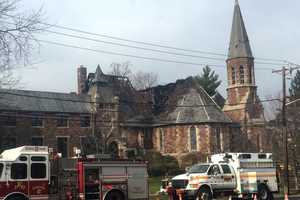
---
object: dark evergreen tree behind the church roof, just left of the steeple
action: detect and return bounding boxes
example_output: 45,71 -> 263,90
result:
196,66 -> 222,96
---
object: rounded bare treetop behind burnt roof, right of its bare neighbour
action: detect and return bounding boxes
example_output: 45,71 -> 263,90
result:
131,71 -> 158,90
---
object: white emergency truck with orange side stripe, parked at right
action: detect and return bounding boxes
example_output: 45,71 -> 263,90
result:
171,153 -> 278,200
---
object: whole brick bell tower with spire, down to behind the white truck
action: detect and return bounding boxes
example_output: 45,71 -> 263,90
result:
223,0 -> 265,151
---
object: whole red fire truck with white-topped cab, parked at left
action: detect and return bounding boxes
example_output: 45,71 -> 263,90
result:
0,146 -> 149,200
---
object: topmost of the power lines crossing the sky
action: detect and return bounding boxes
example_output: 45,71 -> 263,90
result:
3,14 -> 286,62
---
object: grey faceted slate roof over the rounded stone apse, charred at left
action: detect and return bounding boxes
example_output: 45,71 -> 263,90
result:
150,77 -> 232,124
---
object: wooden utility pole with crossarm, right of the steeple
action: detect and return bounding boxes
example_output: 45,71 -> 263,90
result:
272,66 -> 300,194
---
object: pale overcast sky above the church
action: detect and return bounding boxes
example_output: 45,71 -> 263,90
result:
18,0 -> 300,99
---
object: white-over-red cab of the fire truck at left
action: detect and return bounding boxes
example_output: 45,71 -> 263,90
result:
0,146 -> 49,200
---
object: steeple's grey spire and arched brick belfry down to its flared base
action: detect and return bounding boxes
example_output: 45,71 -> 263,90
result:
224,0 -> 262,121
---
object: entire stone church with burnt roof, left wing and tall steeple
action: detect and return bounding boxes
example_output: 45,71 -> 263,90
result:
0,2 -> 265,159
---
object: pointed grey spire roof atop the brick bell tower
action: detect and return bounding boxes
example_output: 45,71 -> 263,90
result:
228,0 -> 253,59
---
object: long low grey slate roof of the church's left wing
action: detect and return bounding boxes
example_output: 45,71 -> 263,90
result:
0,89 -> 90,113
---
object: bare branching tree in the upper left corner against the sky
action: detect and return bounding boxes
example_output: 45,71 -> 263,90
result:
0,0 -> 46,88
